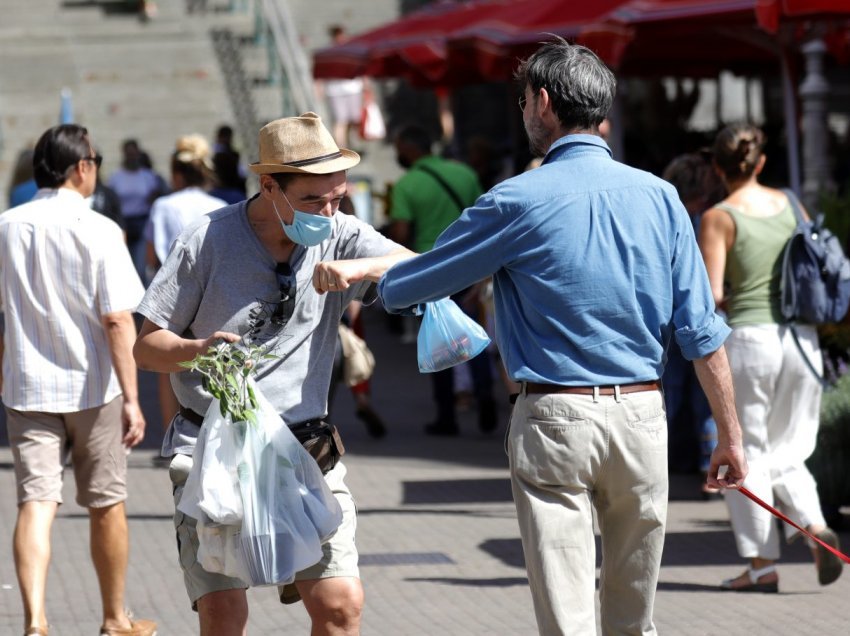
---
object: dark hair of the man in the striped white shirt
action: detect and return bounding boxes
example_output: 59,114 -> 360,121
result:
32,124 -> 91,188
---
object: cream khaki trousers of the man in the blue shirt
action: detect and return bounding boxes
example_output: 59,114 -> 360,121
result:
508,391 -> 668,636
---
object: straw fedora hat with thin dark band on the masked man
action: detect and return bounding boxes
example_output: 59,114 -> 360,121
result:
249,113 -> 360,174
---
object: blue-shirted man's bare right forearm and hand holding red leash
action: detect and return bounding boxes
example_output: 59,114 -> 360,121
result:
694,346 -> 748,488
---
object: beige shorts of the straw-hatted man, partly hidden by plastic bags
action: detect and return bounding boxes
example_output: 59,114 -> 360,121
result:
169,455 -> 360,611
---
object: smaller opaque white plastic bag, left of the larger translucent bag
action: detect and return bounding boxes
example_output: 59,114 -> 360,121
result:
177,399 -> 246,525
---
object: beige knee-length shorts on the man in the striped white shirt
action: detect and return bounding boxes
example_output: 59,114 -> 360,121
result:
6,395 -> 127,508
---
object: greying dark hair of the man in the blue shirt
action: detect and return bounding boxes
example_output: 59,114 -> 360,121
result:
514,37 -> 617,130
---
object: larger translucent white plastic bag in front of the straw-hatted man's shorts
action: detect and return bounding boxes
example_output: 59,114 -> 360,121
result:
239,385 -> 342,585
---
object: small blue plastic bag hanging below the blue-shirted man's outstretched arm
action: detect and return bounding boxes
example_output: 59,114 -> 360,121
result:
416,298 -> 490,373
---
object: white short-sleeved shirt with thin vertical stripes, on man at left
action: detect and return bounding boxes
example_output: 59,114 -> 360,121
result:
0,188 -> 144,413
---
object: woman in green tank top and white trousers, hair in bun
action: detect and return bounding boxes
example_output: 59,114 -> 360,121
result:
699,124 -> 842,592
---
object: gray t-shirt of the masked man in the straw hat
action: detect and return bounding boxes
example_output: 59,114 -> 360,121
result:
138,201 -> 399,457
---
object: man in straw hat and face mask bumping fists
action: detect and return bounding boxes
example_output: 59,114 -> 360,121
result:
135,113 -> 413,636
